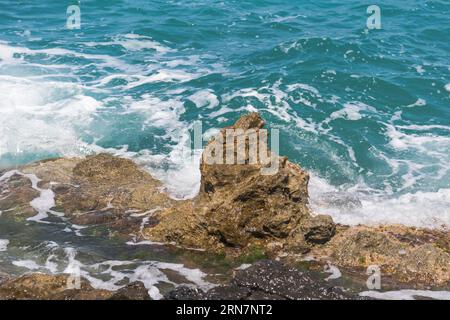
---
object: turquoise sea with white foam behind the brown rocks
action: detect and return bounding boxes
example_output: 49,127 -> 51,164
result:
0,0 -> 450,227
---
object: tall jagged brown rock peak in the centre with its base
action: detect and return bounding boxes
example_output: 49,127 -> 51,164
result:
144,113 -> 334,251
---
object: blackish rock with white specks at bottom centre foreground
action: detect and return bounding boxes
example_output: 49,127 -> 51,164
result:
165,260 -> 366,300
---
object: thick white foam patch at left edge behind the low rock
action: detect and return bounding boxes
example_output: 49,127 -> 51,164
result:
0,76 -> 102,160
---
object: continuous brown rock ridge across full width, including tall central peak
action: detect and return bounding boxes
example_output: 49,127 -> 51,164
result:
0,113 -> 450,288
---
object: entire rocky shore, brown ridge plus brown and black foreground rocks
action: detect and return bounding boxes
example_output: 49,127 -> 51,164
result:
0,113 -> 450,299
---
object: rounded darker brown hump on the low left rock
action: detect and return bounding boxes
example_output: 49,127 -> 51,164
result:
55,154 -> 173,214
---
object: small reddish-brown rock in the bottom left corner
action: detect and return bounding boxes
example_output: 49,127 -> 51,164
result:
0,273 -> 112,300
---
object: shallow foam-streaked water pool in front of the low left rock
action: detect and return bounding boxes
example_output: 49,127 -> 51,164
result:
0,212 -> 230,299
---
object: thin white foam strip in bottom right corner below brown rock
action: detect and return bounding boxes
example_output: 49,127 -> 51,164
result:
359,289 -> 450,300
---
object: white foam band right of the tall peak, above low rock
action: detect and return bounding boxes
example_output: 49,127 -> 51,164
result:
309,174 -> 450,228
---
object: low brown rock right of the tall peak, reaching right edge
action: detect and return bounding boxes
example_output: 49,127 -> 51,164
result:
314,226 -> 450,285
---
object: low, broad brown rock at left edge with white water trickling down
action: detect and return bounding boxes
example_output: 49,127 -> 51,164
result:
0,154 -> 174,236
